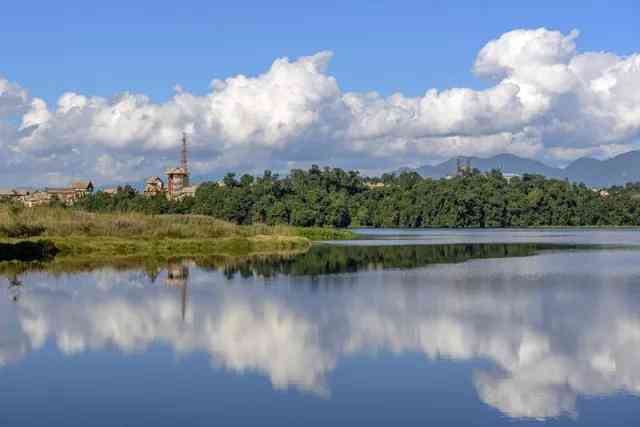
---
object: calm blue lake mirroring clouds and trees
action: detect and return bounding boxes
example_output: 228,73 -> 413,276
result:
0,229 -> 640,427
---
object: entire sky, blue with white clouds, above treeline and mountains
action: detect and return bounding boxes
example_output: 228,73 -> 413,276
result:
0,0 -> 640,186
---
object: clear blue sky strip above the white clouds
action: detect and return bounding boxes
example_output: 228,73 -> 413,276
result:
0,0 -> 640,101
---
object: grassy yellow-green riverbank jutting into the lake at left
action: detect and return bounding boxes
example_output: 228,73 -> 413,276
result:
0,206 -> 354,258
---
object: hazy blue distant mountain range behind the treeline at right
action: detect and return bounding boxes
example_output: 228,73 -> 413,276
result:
398,151 -> 640,187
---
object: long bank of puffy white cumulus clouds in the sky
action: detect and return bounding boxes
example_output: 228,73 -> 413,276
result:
0,28 -> 640,184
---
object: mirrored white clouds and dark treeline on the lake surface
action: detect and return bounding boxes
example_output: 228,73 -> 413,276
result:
0,245 -> 640,418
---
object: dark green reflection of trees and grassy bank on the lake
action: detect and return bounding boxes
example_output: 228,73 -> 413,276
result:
0,243 -> 596,282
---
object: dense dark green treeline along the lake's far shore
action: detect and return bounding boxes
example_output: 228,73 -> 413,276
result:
76,166 -> 640,228
